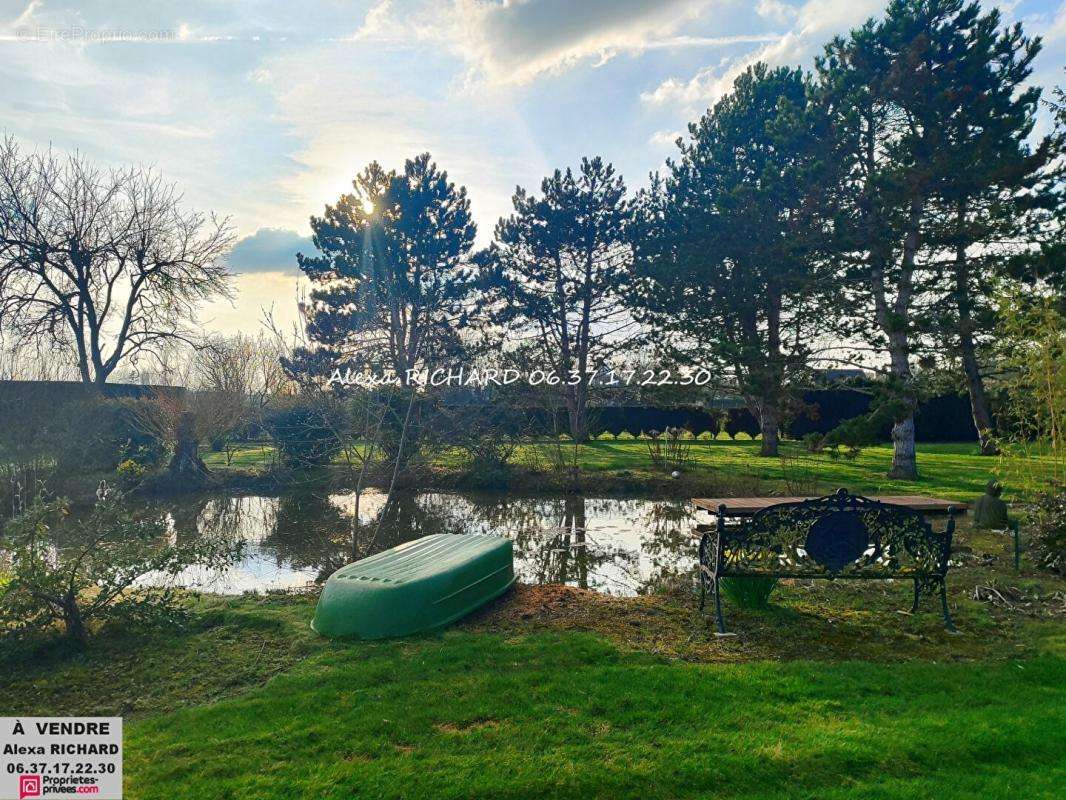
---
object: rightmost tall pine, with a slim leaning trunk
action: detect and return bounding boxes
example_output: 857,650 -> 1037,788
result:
928,3 -> 1062,454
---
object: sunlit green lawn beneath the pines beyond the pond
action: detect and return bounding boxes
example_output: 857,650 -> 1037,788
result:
205,438 -> 1063,500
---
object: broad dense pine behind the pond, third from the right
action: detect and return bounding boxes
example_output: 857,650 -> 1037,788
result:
635,64 -> 839,455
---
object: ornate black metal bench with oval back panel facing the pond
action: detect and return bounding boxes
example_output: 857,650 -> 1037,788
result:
699,489 -> 955,635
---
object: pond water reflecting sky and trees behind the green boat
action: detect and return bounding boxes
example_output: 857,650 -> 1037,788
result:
150,492 -> 697,595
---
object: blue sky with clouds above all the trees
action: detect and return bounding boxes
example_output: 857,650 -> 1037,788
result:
0,0 -> 1066,333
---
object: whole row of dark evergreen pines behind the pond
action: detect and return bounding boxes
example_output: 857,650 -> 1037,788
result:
290,0 -> 1064,478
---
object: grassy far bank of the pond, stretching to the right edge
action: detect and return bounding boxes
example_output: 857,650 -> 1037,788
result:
196,439 -> 1063,501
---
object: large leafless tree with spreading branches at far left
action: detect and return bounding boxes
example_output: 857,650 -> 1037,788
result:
0,138 -> 232,384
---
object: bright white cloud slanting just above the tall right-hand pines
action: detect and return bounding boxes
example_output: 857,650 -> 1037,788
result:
641,0 -> 884,109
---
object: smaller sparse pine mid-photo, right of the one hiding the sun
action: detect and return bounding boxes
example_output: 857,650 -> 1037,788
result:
481,158 -> 632,442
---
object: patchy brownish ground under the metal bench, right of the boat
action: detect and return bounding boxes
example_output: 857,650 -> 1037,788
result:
462,575 -> 1061,662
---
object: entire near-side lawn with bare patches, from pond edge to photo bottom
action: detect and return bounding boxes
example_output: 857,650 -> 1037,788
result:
0,516 -> 1066,800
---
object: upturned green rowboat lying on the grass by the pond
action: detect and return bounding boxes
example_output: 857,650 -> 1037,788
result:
311,533 -> 515,639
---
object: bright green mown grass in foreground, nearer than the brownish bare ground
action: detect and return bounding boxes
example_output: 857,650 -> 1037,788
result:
126,633 -> 1066,799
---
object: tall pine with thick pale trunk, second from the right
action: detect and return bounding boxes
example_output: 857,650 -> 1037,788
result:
817,0 -> 997,480
